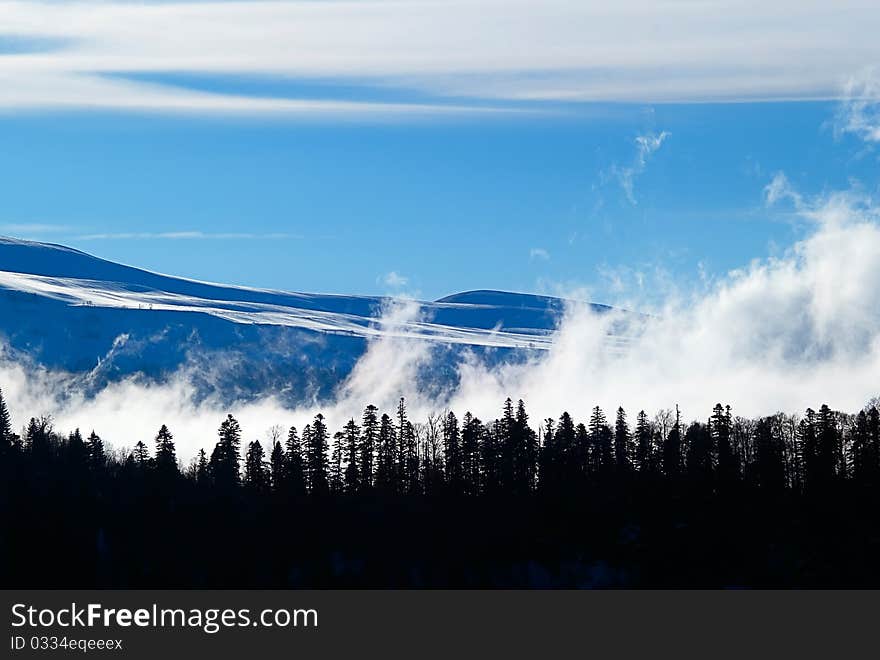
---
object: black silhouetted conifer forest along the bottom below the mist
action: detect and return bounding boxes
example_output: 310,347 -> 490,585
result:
0,386 -> 880,588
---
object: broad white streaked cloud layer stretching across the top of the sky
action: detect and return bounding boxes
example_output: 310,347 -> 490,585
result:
0,0 -> 880,116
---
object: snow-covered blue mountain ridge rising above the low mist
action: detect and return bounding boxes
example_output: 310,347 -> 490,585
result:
0,237 -> 608,403
